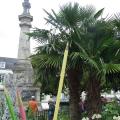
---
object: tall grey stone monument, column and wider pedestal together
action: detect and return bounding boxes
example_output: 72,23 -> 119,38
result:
14,0 -> 40,100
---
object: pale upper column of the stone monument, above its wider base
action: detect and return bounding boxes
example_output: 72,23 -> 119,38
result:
18,0 -> 33,59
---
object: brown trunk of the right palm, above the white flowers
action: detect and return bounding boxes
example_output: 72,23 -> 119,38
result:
86,74 -> 101,118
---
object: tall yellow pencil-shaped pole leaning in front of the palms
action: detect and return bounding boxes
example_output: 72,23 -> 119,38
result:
53,43 -> 68,120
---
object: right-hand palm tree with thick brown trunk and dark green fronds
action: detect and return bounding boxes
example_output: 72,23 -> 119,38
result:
79,15 -> 120,117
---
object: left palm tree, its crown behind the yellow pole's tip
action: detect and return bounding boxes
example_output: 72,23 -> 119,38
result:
29,3 -> 98,120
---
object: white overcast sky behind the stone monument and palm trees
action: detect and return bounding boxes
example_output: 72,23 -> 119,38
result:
0,0 -> 120,58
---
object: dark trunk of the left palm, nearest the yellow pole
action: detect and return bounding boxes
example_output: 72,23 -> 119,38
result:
68,70 -> 80,120
